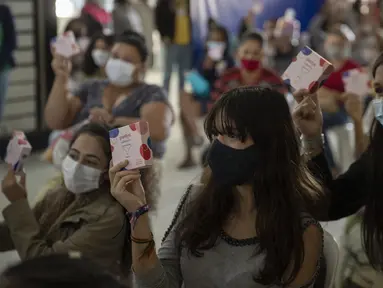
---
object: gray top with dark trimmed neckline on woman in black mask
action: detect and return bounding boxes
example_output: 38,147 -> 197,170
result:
134,185 -> 322,288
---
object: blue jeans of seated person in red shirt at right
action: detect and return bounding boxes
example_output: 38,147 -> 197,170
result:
323,107 -> 348,168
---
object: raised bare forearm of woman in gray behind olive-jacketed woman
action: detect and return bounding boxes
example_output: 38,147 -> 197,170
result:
44,77 -> 70,129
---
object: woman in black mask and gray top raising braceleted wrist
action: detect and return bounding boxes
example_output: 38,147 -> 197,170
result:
109,87 -> 323,288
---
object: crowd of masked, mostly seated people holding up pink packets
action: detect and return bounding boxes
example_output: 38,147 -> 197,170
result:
0,0 -> 383,288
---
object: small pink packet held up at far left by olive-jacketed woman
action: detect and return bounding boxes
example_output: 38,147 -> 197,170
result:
5,131 -> 32,174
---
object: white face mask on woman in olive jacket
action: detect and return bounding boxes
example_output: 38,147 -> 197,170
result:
62,155 -> 102,194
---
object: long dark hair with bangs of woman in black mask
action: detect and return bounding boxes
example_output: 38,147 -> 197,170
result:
177,87 -> 322,285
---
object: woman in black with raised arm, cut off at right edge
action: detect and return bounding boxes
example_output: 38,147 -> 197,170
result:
294,54 -> 383,280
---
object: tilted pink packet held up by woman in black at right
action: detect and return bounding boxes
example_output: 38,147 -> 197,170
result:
282,46 -> 334,93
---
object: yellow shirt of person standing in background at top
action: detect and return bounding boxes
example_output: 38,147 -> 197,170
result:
174,0 -> 191,45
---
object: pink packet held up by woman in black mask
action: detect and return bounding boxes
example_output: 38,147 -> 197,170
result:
109,121 -> 153,170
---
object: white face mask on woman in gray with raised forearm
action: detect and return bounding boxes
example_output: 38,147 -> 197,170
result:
105,58 -> 135,87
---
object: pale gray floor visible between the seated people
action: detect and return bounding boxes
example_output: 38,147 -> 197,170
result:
0,72 -> 343,271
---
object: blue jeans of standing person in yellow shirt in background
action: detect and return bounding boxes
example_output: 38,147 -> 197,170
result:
163,44 -> 192,91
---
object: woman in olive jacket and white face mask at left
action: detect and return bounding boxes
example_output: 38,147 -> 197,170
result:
0,123 -> 154,282
